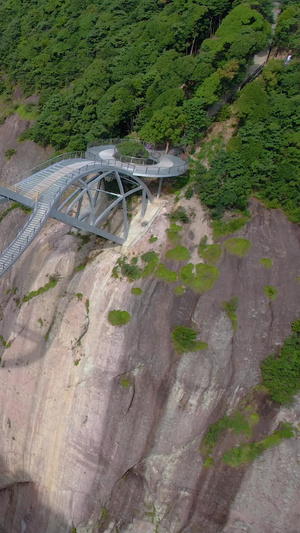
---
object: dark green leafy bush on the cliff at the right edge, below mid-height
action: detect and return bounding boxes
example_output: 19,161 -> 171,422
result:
261,320 -> 300,404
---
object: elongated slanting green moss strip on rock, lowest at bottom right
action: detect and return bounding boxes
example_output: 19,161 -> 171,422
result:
222,423 -> 295,467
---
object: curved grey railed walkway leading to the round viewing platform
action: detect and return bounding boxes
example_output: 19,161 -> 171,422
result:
0,146 -> 187,277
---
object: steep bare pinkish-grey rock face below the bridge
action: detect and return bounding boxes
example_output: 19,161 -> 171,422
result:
0,196 -> 300,533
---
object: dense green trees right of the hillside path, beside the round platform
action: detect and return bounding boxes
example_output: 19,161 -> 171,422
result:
196,60 -> 300,222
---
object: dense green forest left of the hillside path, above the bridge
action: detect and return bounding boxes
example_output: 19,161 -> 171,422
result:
0,0 -> 272,149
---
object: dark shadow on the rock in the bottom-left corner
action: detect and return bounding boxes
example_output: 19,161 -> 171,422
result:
0,457 -> 72,533
